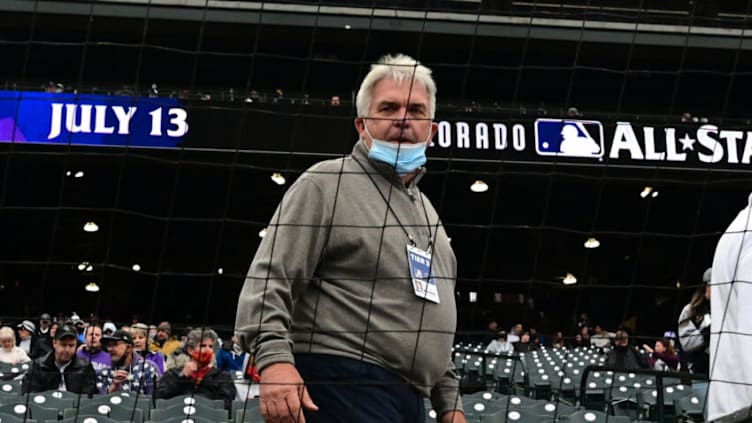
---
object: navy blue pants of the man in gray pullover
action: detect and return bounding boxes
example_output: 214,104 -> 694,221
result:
295,354 -> 426,423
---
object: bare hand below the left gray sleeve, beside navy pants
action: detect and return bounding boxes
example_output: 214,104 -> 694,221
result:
259,363 -> 318,423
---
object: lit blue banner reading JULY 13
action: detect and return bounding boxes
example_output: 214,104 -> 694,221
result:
0,91 -> 188,148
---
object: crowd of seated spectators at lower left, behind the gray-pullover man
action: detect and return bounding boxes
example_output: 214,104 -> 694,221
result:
0,313 -> 258,407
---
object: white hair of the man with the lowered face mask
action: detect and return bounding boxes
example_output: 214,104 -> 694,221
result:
355,54 -> 436,119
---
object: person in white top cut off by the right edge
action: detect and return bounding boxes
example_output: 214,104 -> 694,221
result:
706,195 -> 752,421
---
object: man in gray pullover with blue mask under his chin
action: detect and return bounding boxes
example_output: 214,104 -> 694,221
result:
236,55 -> 465,423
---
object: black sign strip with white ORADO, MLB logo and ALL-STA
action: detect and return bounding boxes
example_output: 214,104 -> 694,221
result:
431,118 -> 752,169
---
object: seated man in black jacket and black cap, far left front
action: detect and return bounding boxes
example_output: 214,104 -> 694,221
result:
23,325 -> 97,394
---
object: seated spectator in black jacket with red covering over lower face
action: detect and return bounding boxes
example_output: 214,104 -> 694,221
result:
155,328 -> 236,409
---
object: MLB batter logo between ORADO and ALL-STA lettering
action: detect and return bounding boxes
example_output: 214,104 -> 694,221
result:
535,119 -> 604,158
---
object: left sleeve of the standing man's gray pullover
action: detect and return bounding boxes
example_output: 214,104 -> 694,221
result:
235,174 -> 330,370
